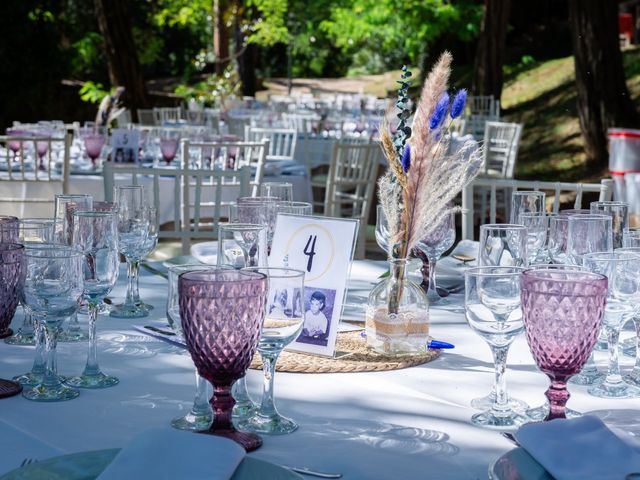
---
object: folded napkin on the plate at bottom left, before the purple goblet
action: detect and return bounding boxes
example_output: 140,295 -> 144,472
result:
98,428 -> 245,480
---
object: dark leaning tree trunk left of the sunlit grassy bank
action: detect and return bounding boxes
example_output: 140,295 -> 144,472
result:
472,0 -> 511,100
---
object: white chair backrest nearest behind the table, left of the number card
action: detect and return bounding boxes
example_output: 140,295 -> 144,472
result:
103,162 -> 251,254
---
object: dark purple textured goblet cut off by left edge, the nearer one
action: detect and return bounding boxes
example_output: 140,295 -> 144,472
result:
0,243 -> 25,338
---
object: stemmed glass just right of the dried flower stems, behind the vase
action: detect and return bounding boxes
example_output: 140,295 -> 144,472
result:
415,215 -> 456,305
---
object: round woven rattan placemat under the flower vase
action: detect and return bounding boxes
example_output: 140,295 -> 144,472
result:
250,332 -> 440,373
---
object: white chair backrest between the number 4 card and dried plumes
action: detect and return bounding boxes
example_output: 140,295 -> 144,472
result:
324,142 -> 382,258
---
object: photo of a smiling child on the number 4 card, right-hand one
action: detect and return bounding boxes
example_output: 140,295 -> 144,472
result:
296,288 -> 336,346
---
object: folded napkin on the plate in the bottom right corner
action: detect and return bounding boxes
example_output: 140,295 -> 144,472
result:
515,416 -> 640,480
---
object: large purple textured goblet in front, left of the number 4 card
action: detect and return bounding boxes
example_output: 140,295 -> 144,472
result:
178,270 -> 268,452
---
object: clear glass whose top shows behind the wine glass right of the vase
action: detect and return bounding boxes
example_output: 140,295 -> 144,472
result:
478,223 -> 527,267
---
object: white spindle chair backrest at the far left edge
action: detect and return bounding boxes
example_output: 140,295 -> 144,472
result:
0,133 -> 73,217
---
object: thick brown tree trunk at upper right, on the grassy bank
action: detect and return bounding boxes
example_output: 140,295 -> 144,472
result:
569,0 -> 639,167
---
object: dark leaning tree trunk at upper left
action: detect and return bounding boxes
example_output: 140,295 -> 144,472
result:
94,0 -> 149,119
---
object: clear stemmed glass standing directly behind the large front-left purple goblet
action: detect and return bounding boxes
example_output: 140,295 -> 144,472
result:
217,223 -> 267,421
